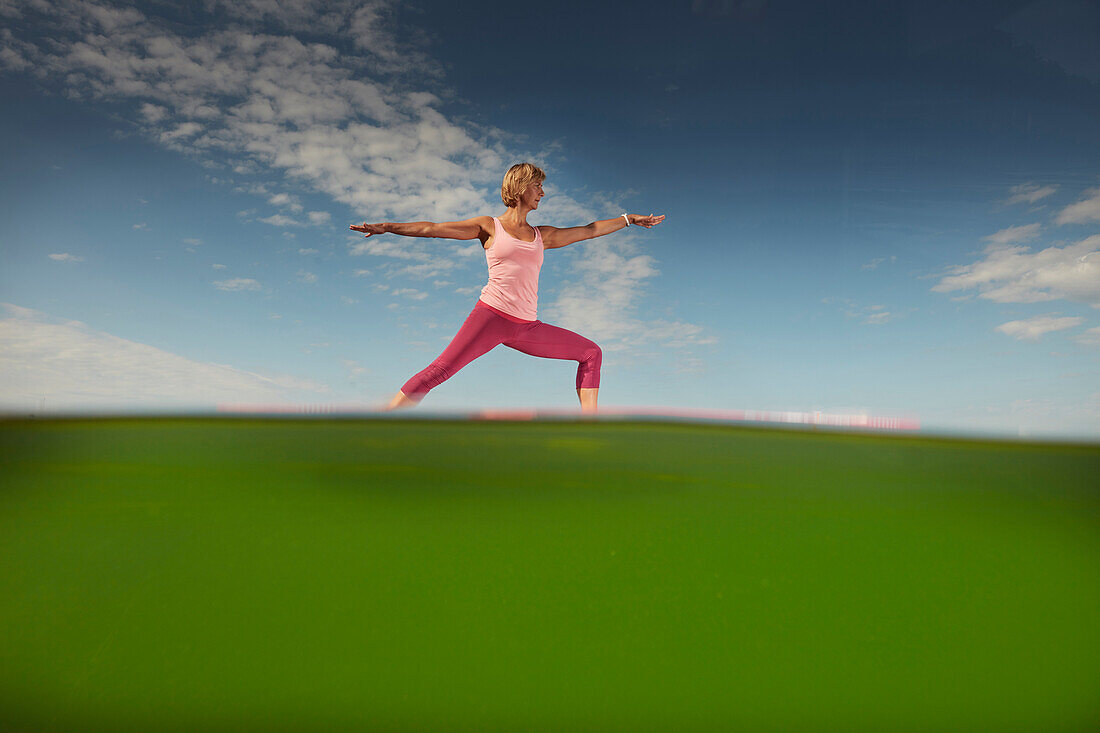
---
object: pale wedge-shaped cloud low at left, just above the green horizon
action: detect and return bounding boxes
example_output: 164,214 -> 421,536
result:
0,304 -> 330,412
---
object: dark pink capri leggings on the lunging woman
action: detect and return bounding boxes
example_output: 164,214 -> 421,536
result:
402,299 -> 604,401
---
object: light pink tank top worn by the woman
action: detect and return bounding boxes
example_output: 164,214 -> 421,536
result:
481,217 -> 542,320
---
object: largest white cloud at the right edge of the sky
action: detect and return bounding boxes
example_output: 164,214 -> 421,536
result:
932,234 -> 1100,308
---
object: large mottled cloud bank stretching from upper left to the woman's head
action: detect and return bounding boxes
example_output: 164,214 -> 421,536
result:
0,0 -> 508,220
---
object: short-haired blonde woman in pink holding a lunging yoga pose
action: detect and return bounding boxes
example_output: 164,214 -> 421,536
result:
350,163 -> 664,414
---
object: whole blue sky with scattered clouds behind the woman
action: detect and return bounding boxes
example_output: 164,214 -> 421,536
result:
0,0 -> 1100,439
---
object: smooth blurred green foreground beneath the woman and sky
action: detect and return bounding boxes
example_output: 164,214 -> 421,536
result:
0,418 -> 1100,732
